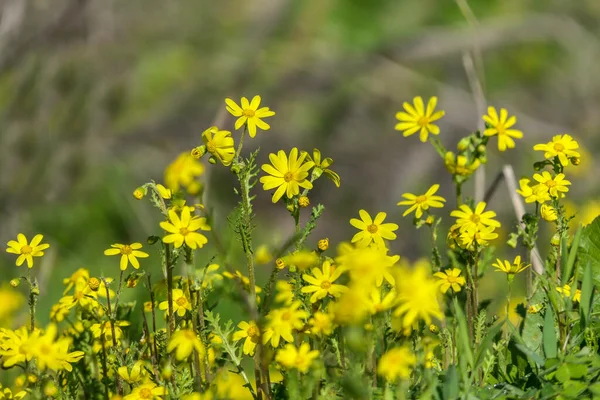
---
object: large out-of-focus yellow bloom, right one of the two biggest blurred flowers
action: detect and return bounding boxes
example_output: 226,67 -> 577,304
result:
394,265 -> 444,327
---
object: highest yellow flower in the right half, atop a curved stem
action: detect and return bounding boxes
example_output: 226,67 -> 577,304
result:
395,96 -> 445,143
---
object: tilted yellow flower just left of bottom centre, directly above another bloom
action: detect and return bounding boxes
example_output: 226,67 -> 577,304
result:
263,301 -> 308,348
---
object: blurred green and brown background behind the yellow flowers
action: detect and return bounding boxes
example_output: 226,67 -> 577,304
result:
0,0 -> 600,330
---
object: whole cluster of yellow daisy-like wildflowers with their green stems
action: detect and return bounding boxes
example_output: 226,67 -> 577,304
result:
0,92 -> 581,400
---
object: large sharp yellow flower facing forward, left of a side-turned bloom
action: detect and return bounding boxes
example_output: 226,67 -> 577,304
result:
260,147 -> 315,203
